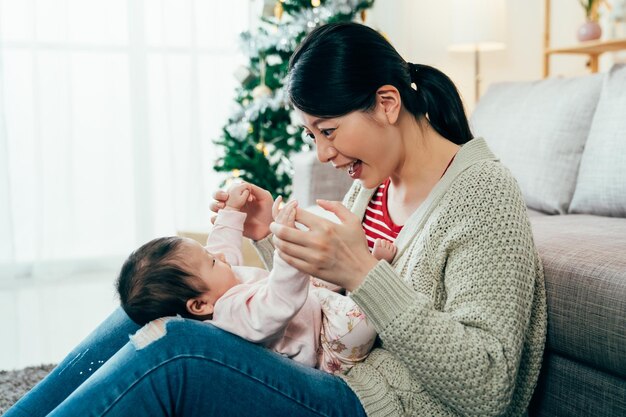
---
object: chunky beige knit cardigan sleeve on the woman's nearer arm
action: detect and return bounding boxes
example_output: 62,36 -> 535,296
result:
351,164 -> 539,415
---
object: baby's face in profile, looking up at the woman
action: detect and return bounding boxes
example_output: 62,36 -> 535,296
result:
182,239 -> 240,305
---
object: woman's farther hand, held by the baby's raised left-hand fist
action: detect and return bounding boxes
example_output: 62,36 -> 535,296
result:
209,183 -> 274,240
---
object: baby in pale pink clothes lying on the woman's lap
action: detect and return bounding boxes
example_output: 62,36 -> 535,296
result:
117,183 -> 395,373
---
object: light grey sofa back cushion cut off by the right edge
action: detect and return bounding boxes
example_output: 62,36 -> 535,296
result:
570,65 -> 626,217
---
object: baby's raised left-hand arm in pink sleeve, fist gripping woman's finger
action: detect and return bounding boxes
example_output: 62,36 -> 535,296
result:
206,183 -> 250,266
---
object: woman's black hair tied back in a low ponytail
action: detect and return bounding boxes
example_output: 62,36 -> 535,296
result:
287,22 -> 473,145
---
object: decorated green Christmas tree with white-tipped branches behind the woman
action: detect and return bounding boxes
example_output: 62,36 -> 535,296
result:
214,0 -> 374,198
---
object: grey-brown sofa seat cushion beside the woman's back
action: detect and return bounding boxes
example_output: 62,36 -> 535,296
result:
530,215 -> 626,377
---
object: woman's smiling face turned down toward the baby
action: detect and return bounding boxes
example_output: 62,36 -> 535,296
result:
296,105 -> 398,188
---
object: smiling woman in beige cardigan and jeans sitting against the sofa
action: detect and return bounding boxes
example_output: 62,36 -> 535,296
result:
7,23 -> 546,417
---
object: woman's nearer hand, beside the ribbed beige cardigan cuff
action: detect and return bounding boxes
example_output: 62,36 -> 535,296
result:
270,200 -> 378,291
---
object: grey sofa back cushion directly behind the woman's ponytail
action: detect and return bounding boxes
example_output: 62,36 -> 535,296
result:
472,74 -> 602,213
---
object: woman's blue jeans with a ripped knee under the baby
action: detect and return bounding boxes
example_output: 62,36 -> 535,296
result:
4,308 -> 365,417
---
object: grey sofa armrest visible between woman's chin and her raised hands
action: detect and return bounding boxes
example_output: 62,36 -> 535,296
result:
291,151 -> 352,207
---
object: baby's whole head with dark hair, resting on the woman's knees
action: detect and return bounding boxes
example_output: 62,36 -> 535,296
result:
117,237 -> 239,325
